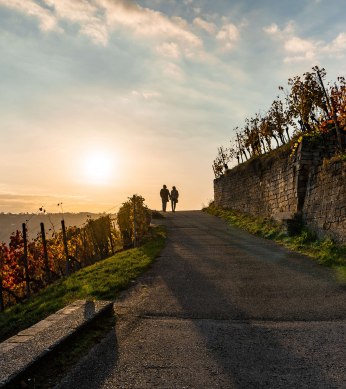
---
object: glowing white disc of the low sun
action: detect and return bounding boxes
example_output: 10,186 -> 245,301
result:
83,151 -> 115,185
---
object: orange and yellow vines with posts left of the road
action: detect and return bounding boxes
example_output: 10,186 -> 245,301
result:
0,195 -> 151,312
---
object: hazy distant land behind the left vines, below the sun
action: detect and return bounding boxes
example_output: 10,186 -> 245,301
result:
0,212 -> 115,243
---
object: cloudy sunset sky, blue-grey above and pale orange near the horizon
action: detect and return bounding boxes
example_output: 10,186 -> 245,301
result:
0,0 -> 346,213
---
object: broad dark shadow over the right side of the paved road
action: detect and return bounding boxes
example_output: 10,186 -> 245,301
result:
155,211 -> 345,388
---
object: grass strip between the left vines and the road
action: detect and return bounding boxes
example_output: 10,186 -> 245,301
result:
0,223 -> 166,341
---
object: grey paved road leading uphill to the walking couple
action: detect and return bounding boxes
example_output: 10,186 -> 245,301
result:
57,211 -> 346,389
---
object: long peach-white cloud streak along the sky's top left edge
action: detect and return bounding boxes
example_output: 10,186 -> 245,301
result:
0,0 -> 203,56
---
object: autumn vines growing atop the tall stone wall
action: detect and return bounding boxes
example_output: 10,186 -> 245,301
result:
212,66 -> 346,178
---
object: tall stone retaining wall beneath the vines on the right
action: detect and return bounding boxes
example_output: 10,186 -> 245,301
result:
214,140 -> 346,243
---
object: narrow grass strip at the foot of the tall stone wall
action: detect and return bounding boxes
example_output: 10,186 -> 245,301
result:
203,204 -> 346,280
